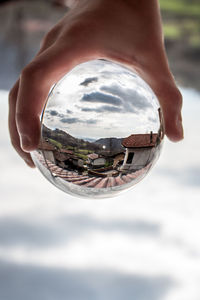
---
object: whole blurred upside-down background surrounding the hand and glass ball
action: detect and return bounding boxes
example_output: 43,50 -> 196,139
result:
0,0 -> 200,300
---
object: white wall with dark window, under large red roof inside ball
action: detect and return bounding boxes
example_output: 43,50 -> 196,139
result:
120,147 -> 155,170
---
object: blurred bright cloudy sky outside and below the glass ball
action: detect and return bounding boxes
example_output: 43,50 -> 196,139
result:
0,89 -> 200,300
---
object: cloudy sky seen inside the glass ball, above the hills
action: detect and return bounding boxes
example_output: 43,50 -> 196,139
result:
43,60 -> 160,140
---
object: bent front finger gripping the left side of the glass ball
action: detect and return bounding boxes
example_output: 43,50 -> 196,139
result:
16,43 -> 83,152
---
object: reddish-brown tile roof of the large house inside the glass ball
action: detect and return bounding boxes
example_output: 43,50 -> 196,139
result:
122,133 -> 158,148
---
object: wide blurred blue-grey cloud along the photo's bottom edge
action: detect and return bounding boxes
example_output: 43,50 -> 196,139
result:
0,258 -> 173,300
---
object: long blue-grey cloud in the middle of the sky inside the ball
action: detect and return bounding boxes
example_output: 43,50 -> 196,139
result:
81,92 -> 122,106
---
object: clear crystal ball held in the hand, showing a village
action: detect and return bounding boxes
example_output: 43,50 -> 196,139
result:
31,59 -> 164,198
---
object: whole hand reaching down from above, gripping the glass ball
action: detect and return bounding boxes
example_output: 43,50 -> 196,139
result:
9,0 -> 183,167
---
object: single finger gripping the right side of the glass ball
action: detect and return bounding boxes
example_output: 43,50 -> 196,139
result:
138,48 -> 184,142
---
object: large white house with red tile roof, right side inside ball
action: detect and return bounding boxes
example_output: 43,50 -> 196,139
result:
120,132 -> 159,171
